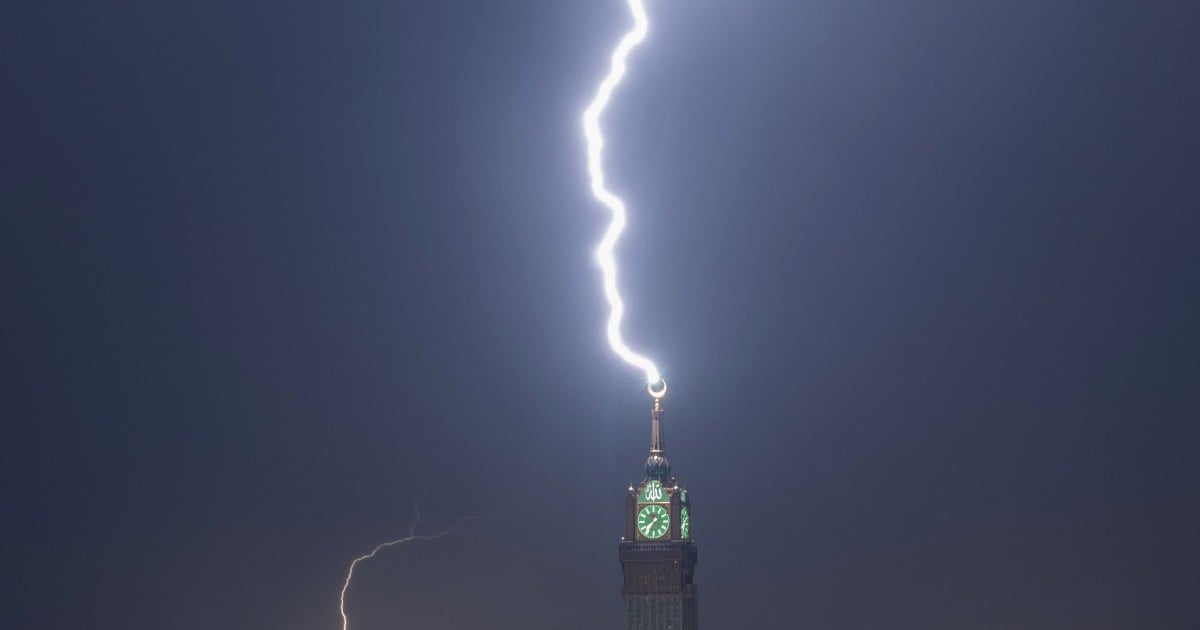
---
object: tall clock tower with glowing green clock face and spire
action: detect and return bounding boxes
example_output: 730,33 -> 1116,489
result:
618,391 -> 700,630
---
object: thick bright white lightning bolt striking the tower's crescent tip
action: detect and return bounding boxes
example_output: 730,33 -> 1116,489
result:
583,0 -> 666,395
